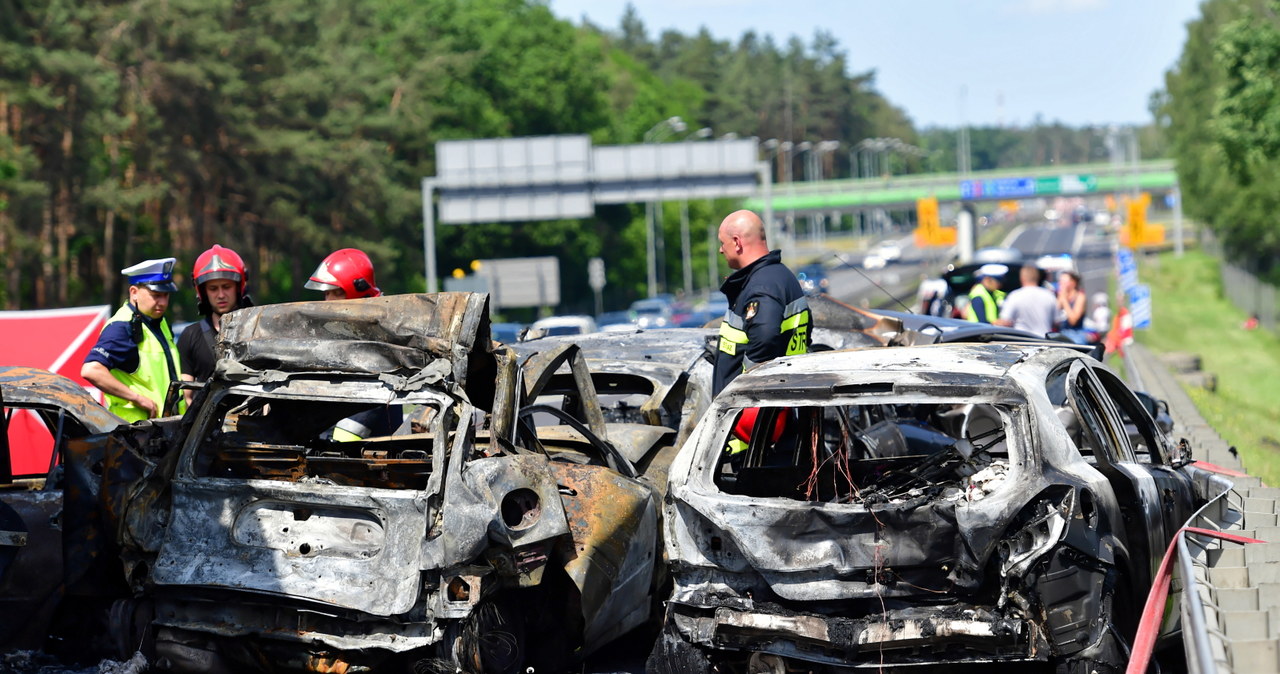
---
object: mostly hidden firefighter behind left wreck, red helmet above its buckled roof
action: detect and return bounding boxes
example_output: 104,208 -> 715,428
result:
306,248 -> 403,443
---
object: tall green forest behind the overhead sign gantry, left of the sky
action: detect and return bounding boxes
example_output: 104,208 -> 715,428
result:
0,0 -> 1162,318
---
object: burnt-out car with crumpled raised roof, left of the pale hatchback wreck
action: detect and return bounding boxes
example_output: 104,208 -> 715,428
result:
76,293 -> 675,671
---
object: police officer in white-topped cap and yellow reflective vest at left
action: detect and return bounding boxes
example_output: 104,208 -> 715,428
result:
81,257 -> 186,422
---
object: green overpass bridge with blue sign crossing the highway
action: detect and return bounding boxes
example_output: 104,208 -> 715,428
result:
744,160 -> 1178,214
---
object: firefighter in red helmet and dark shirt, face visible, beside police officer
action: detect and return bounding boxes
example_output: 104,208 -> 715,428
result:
178,243 -> 253,388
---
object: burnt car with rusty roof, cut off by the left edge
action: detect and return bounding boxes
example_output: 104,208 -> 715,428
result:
0,367 -> 125,650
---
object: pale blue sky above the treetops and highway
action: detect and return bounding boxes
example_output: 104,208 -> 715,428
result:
549,0 -> 1199,128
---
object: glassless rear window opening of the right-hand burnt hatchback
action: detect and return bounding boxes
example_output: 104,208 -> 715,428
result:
716,398 -> 1016,504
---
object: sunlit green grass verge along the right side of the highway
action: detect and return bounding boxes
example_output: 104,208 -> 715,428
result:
1137,251 -> 1280,485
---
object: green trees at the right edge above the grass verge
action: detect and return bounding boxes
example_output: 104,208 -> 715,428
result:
1157,0 -> 1280,284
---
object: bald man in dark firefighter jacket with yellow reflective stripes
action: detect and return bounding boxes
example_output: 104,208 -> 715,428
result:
713,211 -> 812,394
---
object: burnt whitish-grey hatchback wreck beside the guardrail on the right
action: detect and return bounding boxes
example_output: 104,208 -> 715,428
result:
649,344 -> 1201,673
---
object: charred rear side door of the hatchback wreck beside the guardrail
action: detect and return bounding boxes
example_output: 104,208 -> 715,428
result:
1066,359 -> 1169,587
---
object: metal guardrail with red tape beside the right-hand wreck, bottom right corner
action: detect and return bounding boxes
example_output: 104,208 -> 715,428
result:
1125,462 -> 1265,674
